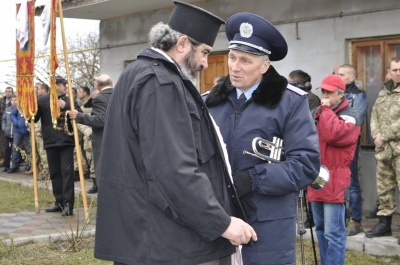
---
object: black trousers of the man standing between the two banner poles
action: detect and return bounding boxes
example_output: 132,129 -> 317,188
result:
46,146 -> 75,210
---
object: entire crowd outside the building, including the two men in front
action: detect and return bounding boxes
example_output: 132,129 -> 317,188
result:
0,1 -> 400,265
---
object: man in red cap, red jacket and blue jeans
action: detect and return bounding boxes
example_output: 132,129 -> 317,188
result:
307,75 -> 360,264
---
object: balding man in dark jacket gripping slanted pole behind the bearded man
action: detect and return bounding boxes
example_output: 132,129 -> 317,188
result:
69,75 -> 113,193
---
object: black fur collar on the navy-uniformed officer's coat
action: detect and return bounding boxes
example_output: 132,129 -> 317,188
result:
206,65 -> 288,108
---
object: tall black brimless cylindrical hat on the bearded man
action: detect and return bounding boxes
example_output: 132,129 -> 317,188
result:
168,1 -> 225,46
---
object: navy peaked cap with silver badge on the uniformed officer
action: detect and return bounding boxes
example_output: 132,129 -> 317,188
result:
225,13 -> 288,61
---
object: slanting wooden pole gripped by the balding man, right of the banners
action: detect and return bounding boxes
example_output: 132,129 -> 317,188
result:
57,0 -> 89,223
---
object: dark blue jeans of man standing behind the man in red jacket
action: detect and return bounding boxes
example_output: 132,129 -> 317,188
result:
349,139 -> 362,223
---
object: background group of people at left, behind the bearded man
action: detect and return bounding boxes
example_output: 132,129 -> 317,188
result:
0,75 -> 113,216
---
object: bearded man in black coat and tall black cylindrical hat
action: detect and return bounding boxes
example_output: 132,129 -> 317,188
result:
94,1 -> 256,265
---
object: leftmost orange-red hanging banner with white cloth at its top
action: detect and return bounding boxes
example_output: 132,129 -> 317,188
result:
17,1 -> 37,119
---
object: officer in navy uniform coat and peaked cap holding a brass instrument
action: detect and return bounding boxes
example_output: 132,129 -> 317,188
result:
206,13 -> 320,264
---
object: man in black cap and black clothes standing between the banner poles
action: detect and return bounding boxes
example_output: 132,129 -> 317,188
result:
35,77 -> 81,216
